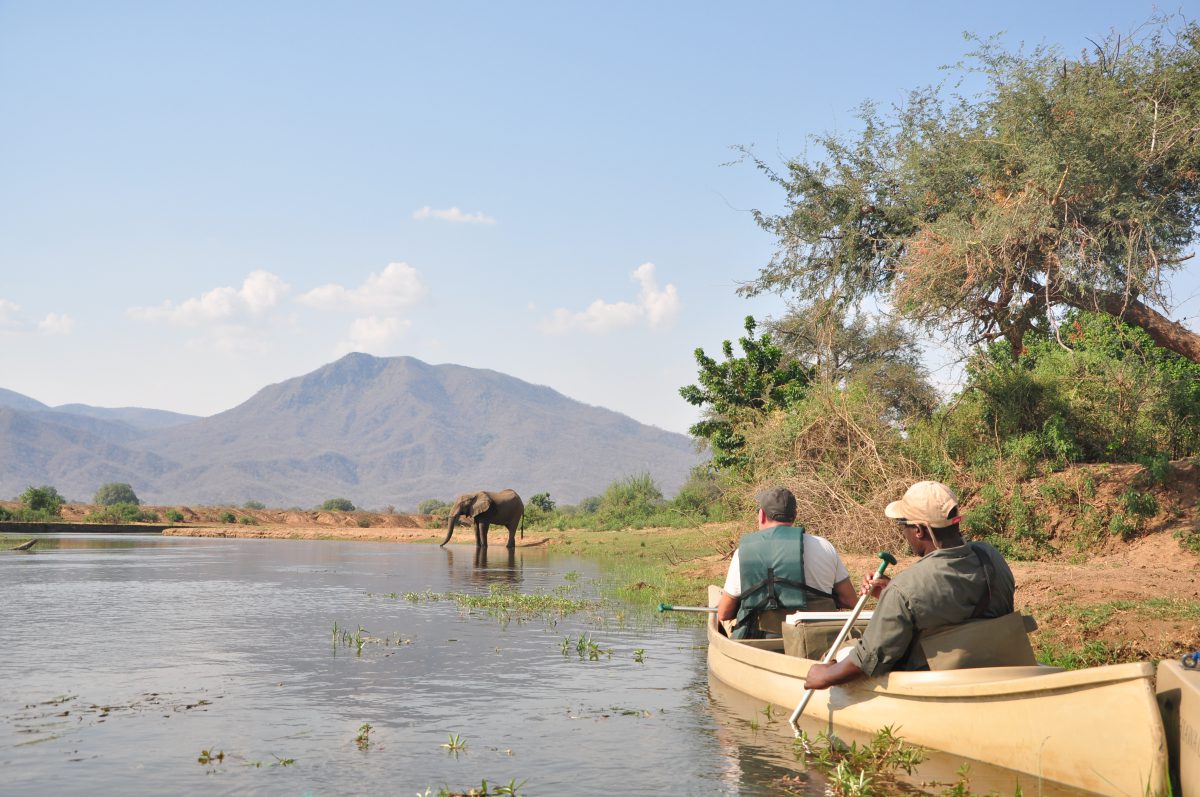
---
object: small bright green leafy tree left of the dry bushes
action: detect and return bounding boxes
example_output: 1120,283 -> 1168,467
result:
679,316 -> 812,468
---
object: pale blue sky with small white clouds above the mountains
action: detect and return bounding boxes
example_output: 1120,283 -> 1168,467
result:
0,0 -> 1200,432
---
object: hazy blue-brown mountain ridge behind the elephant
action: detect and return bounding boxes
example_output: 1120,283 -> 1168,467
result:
0,354 -> 701,509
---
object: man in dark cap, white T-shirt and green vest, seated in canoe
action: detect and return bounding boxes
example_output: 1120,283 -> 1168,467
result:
716,487 -> 857,640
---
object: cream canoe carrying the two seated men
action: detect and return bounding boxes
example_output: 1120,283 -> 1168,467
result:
708,587 -> 1168,797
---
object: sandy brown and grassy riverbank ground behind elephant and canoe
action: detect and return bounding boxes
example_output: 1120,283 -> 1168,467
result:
150,523 -> 1200,667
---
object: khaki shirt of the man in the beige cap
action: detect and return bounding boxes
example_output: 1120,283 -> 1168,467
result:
850,543 -> 1015,676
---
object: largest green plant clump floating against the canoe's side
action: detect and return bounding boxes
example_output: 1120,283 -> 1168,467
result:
792,724 -> 931,797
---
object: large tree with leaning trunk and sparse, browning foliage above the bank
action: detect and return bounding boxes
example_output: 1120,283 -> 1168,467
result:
740,20 -> 1200,362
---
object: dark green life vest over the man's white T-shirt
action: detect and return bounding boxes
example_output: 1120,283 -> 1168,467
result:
732,526 -> 833,640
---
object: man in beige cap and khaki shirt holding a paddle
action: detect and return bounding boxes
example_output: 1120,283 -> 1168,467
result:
804,481 -> 1015,689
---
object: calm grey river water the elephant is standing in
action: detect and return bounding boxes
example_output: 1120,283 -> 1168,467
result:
0,535 -> 1089,797
